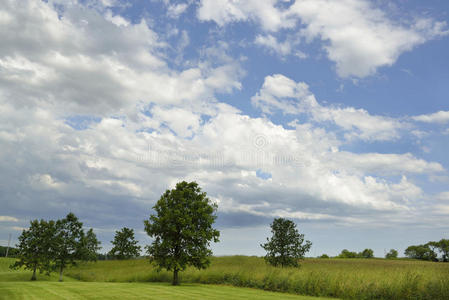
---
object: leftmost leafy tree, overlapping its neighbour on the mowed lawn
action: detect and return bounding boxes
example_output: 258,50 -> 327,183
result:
10,220 -> 55,280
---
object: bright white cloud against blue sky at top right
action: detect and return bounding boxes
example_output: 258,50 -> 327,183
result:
198,0 -> 449,78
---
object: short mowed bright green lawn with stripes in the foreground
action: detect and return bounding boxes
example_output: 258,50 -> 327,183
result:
0,258 -> 329,300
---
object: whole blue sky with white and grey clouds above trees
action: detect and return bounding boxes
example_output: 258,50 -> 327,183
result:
0,0 -> 449,257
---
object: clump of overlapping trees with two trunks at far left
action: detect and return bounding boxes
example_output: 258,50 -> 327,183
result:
10,213 -> 100,281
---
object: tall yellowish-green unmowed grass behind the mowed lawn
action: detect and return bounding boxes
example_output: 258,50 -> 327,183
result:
67,256 -> 449,299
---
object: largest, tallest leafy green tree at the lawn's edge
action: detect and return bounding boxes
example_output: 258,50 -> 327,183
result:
144,181 -> 220,285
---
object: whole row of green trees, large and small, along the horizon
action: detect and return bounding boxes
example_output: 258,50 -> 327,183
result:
7,181 -> 448,285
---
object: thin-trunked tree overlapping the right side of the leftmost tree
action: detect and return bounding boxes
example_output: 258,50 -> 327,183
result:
52,213 -> 85,281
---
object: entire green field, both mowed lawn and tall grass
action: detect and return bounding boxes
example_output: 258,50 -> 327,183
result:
0,256 -> 449,300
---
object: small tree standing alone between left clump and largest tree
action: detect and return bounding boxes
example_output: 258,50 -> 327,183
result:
109,227 -> 140,259
